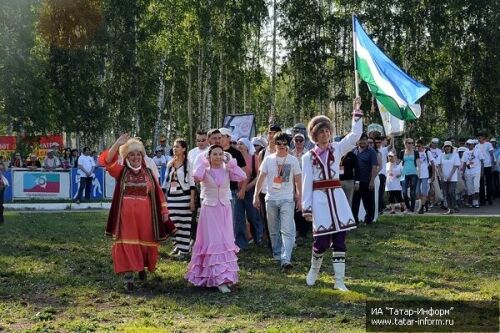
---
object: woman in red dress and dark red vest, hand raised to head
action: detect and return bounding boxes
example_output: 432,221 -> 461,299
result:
99,133 -> 175,290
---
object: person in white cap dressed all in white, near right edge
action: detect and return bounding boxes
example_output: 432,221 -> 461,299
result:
462,139 -> 484,208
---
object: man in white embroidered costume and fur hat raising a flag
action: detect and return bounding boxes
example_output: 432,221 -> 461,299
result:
302,97 -> 363,291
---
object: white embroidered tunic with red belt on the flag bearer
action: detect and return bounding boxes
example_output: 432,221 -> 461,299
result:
302,120 -> 363,236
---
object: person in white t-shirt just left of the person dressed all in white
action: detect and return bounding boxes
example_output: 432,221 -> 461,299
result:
436,141 -> 460,215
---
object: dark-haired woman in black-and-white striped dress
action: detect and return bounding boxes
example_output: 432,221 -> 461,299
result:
163,139 -> 195,259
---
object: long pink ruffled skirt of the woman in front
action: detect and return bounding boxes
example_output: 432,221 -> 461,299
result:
185,167 -> 240,287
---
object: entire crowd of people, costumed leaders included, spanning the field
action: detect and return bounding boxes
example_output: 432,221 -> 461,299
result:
0,99 -> 500,293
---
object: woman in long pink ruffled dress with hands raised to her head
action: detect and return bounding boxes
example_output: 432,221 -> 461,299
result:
186,145 -> 246,293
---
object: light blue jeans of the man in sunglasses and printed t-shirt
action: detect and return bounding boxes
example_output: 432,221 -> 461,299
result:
266,199 -> 295,265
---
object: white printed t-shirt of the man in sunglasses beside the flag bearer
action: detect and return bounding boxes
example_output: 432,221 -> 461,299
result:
259,153 -> 302,200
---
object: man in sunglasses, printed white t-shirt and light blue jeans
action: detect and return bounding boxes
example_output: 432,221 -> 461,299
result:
253,132 -> 302,271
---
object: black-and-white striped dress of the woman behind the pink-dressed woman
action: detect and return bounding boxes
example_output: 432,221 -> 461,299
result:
164,164 -> 194,253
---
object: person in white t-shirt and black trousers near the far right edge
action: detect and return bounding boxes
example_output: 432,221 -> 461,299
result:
476,133 -> 495,205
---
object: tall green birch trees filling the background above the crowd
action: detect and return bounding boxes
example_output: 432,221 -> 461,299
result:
0,0 -> 500,148
